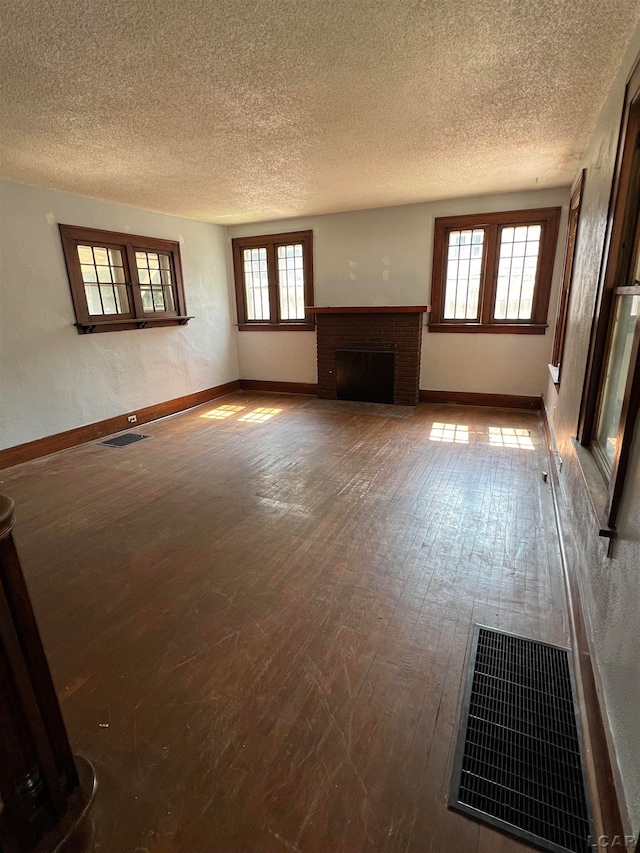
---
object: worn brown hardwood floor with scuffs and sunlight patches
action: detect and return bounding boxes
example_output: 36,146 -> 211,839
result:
0,392 -> 568,853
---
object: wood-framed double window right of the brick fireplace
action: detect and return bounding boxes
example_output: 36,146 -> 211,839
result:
429,207 -> 560,335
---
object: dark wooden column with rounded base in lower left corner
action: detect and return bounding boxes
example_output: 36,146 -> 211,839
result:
0,495 -> 95,853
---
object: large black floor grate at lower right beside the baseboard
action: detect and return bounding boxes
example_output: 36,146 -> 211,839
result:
449,625 -> 592,853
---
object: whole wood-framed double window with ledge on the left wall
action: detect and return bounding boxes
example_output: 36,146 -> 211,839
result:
60,225 -> 191,334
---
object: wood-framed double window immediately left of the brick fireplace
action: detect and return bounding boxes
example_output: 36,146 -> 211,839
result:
232,231 -> 315,331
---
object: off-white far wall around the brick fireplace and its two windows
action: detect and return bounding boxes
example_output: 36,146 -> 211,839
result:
229,188 -> 569,396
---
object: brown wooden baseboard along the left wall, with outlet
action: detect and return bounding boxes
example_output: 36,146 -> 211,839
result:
0,379 -> 240,470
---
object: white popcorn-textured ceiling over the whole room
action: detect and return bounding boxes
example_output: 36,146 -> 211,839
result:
0,0 -> 640,223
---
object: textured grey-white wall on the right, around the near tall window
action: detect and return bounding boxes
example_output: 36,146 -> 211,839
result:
546,25 -> 640,832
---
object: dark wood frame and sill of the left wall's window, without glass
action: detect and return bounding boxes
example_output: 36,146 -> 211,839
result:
59,225 -> 192,334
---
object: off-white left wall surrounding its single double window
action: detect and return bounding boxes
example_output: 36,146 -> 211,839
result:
0,181 -> 239,448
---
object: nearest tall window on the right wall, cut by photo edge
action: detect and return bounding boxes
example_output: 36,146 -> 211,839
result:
578,58 -> 640,528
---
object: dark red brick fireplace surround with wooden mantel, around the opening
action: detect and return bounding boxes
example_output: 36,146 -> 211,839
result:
312,305 -> 427,406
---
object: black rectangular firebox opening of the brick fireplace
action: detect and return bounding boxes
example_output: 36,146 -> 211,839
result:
336,350 -> 395,403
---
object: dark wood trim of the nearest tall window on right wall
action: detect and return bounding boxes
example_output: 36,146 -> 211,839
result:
577,55 -> 640,529
